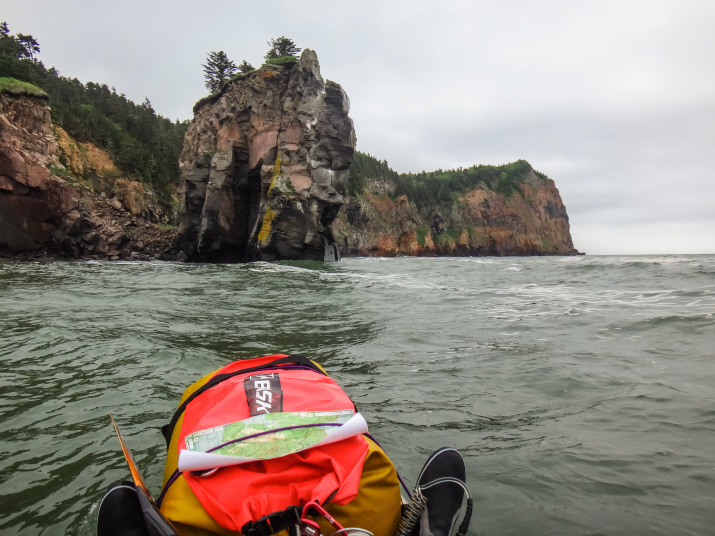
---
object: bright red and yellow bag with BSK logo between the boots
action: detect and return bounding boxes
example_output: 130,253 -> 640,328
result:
160,355 -> 400,536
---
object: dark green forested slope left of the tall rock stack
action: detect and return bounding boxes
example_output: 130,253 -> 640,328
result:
0,23 -> 188,206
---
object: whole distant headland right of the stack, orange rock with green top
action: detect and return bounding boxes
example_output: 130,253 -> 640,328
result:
332,154 -> 579,257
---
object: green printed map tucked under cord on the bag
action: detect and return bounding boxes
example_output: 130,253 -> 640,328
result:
186,410 -> 354,460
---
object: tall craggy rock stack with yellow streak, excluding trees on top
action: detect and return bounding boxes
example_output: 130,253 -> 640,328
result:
178,50 -> 355,262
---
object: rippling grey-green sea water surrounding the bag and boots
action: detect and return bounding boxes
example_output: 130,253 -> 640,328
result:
0,256 -> 715,536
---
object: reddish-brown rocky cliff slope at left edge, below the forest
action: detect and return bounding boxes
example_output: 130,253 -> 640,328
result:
0,84 -> 176,259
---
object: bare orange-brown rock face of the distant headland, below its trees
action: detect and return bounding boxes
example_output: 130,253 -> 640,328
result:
332,171 -> 578,257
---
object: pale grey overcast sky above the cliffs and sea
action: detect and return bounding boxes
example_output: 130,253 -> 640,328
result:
0,0 -> 715,254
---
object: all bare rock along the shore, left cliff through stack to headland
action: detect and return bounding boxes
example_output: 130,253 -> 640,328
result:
0,50 -> 579,262
